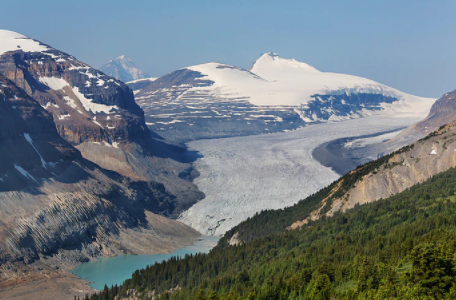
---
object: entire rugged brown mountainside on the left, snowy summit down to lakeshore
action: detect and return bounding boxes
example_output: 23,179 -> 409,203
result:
0,30 -> 203,299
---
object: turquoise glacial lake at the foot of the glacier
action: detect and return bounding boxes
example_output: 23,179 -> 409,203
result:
71,236 -> 220,290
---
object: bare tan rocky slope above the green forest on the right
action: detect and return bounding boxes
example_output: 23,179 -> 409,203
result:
291,117 -> 456,228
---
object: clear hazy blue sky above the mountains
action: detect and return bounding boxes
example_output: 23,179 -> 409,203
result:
0,0 -> 456,97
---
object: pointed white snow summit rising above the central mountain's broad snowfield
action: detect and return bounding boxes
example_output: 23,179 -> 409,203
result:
249,52 -> 320,80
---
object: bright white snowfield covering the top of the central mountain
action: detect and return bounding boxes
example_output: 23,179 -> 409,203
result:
183,53 -> 435,118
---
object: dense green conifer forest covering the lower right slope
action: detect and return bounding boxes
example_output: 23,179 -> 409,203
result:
85,165 -> 456,300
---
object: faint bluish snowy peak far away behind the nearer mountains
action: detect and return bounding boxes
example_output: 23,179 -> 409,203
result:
100,55 -> 150,82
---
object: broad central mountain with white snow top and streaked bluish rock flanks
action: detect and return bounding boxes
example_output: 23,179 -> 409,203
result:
136,53 -> 435,141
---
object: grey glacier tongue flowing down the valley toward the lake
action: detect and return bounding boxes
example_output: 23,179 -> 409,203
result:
179,117 -> 418,235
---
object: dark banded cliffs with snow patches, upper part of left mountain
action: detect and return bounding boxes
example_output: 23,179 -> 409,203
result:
0,32 -> 150,145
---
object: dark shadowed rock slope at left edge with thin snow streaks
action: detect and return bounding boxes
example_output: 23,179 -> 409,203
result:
0,75 -> 82,192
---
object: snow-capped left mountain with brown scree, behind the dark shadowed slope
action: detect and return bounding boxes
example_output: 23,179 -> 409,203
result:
0,30 -> 203,214
